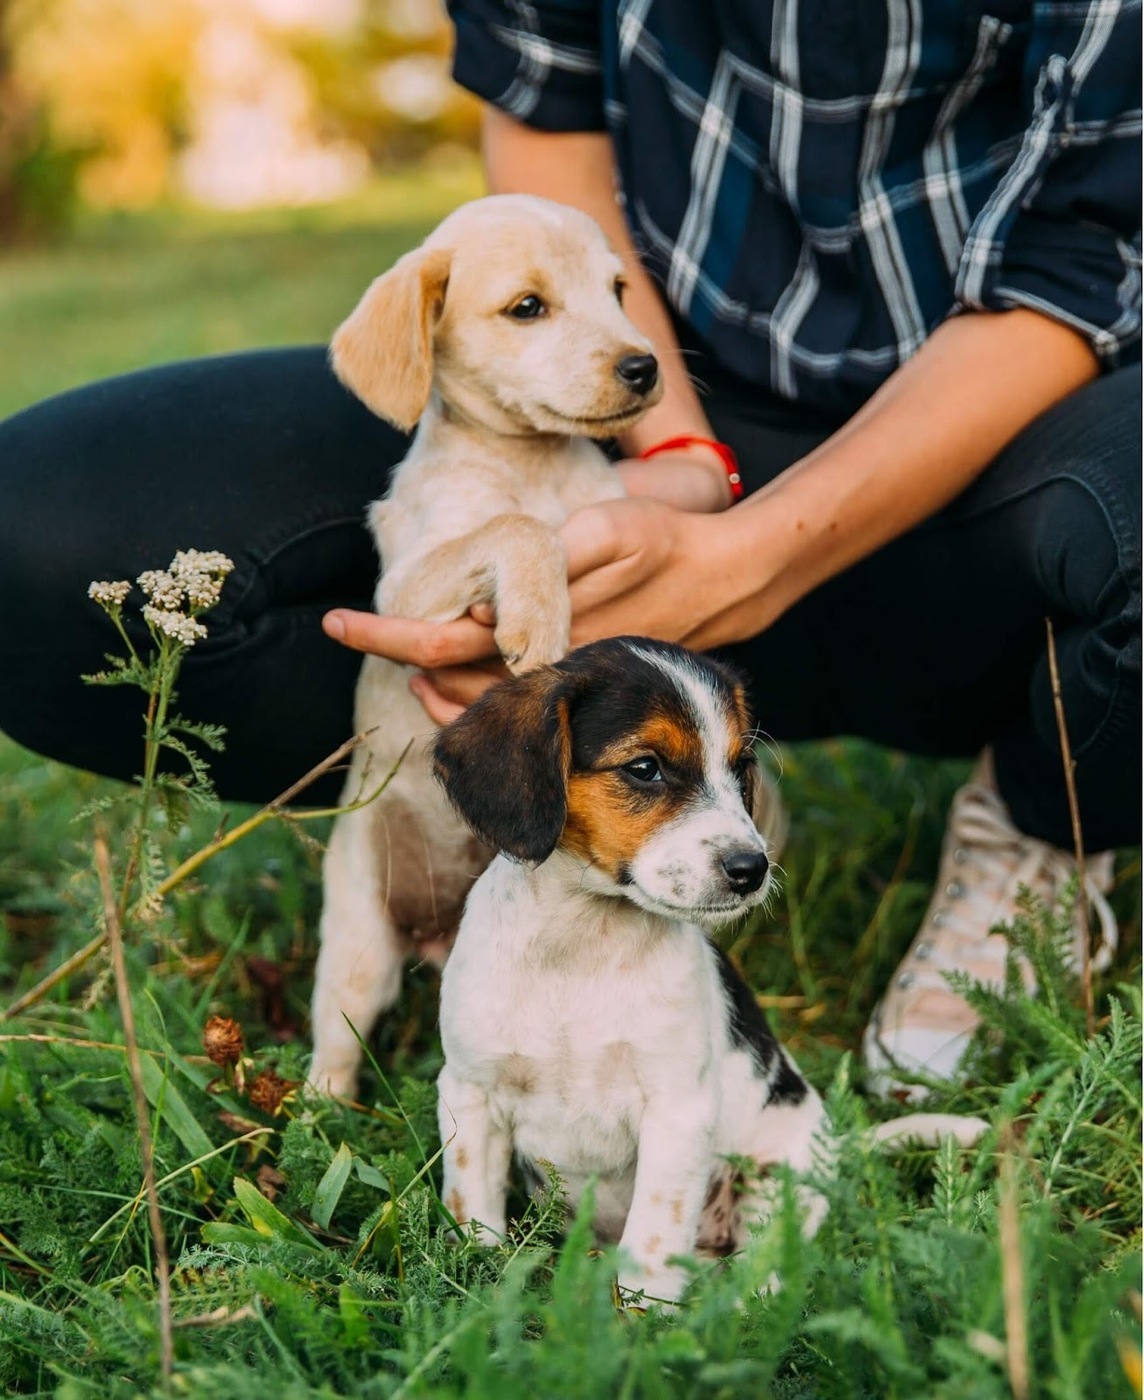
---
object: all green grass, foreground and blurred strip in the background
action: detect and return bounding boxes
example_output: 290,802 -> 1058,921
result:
0,171 -> 1140,1400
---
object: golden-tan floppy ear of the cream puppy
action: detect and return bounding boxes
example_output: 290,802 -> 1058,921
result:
329,248 -> 452,433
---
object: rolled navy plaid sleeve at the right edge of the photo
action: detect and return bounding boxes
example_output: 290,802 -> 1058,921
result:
956,0 -> 1141,368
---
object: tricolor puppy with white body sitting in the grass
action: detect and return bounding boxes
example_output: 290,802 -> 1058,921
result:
434,637 -> 986,1302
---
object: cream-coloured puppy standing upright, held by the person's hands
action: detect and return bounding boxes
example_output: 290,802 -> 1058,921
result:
311,196 -> 662,1093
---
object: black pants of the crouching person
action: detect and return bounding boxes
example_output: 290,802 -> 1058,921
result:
0,347 -> 1140,850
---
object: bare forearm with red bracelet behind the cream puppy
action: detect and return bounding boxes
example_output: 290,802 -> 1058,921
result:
482,108 -> 730,510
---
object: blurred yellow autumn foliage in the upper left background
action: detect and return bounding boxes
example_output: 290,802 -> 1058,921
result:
0,0 -> 477,228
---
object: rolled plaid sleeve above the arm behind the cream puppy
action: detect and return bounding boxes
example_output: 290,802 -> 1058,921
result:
448,0 -> 605,132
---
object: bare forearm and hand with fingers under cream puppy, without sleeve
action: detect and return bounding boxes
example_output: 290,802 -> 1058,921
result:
326,301 -> 1096,722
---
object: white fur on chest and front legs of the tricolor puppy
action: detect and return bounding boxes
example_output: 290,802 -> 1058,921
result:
440,851 -> 821,1298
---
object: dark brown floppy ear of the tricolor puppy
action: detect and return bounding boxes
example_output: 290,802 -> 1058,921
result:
433,666 -> 571,861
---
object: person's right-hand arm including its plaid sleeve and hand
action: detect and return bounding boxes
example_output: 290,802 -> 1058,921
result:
322,0 -> 1140,711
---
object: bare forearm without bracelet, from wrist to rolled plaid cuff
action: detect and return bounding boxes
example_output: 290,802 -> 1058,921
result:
714,309 -> 1096,644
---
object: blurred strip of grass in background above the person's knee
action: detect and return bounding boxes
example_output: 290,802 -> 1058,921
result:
0,164 -> 480,416
